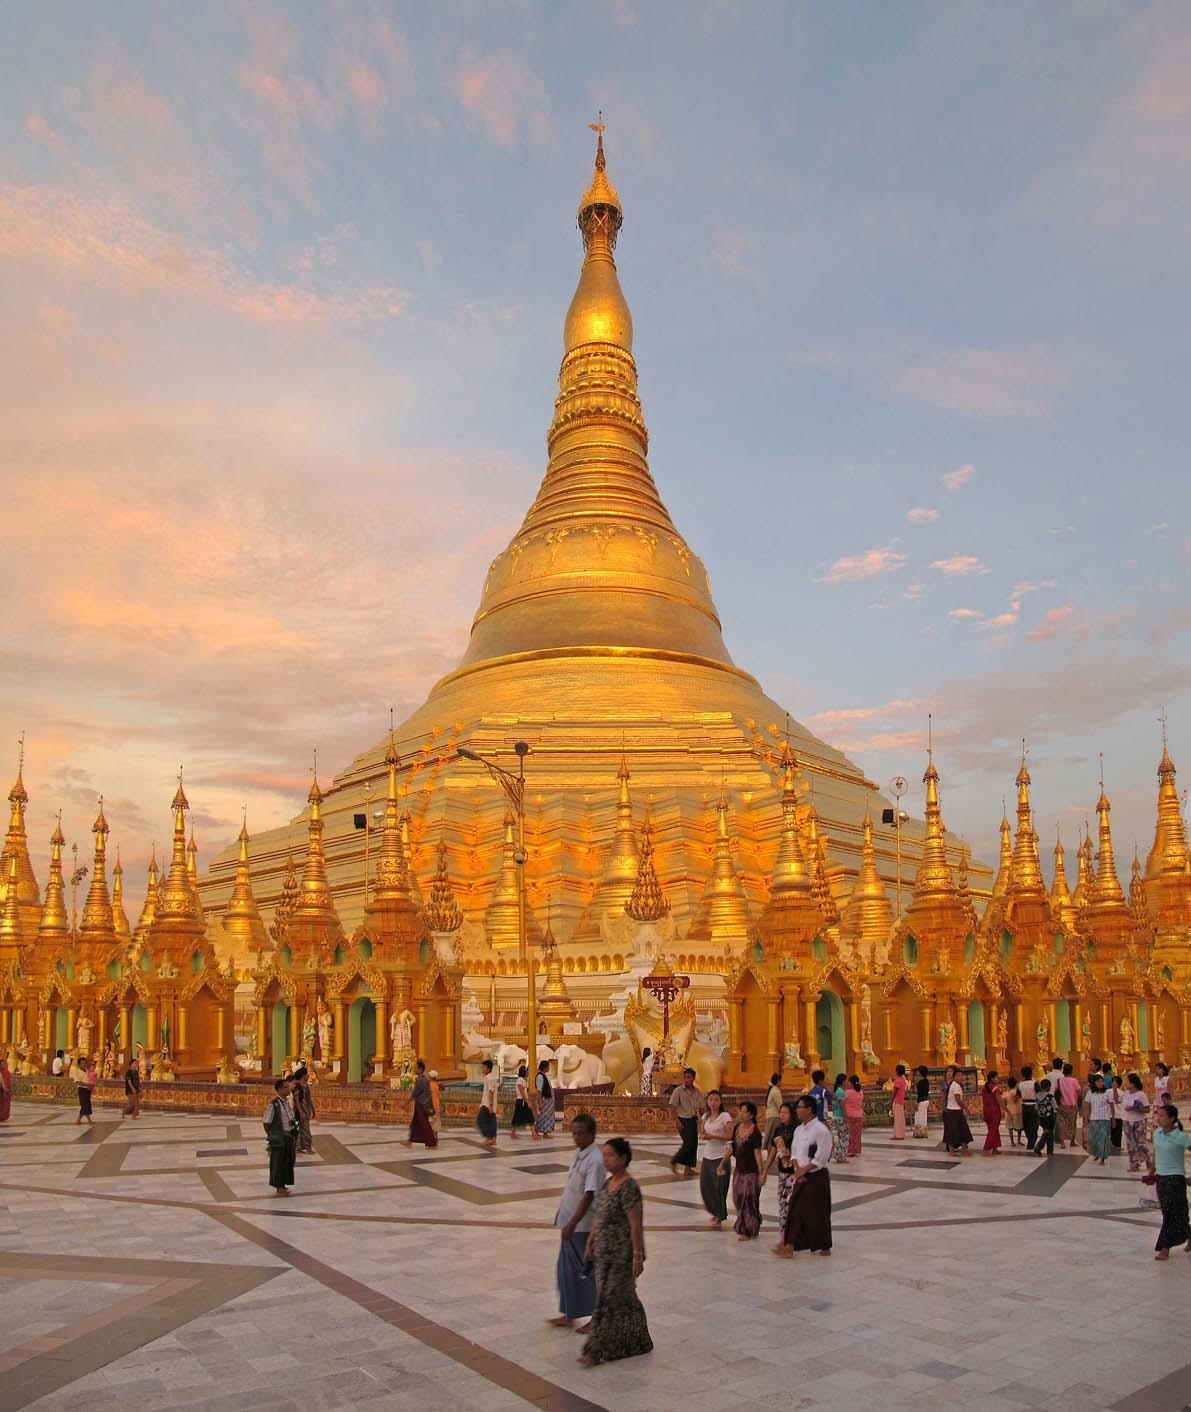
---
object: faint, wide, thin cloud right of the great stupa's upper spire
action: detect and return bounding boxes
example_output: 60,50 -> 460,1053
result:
788,336 -> 1109,419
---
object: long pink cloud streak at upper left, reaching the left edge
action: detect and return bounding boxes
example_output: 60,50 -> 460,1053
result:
0,186 -> 398,328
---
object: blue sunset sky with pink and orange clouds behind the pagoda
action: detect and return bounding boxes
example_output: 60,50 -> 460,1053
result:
0,0 -> 1191,909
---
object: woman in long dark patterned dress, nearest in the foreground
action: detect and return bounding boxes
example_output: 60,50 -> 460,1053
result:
579,1138 -> 653,1368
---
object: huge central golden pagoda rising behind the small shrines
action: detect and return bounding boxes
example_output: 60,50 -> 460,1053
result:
202,127 -> 983,1008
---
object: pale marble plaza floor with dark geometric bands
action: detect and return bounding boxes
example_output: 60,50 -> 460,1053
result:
0,1104 -> 1191,1412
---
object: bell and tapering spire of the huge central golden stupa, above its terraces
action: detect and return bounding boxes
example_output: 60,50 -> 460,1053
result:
432,124 -> 734,695
